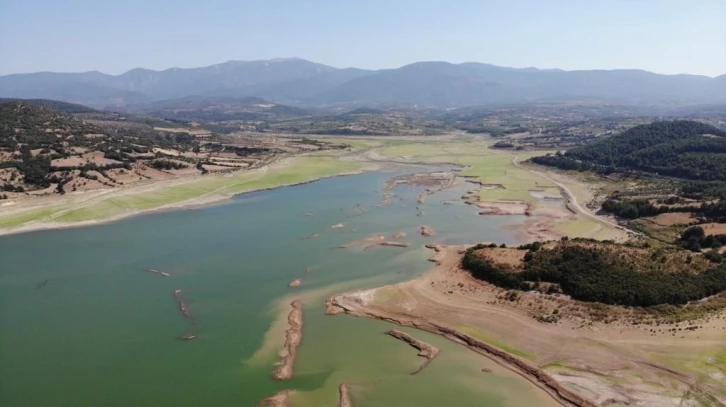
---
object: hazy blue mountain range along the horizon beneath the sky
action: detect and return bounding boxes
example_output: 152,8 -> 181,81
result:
0,58 -> 726,107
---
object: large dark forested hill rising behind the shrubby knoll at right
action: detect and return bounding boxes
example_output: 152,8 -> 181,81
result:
532,120 -> 726,181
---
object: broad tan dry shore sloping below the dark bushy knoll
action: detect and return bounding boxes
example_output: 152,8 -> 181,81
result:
326,246 -> 726,407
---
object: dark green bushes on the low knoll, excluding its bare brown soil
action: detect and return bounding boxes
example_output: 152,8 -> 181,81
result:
462,244 -> 726,307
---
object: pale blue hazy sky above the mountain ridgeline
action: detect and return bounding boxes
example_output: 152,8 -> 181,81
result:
0,0 -> 726,76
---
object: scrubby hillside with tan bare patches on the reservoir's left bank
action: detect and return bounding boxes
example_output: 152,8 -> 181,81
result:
0,101 -> 345,195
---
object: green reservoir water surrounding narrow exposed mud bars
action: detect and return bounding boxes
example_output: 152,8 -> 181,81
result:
0,173 -> 546,407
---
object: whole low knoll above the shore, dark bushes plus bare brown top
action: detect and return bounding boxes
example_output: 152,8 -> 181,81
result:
462,240 -> 726,306
